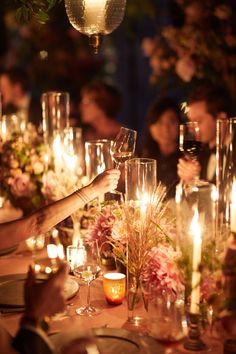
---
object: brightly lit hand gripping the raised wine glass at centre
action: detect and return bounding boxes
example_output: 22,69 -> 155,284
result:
87,169 -> 120,198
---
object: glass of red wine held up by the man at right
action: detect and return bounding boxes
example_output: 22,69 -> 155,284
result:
179,121 -> 202,160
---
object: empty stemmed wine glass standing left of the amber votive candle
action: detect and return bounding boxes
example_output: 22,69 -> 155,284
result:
73,250 -> 101,317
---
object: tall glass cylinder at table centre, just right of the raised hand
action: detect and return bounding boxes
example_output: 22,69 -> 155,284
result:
125,158 -> 157,326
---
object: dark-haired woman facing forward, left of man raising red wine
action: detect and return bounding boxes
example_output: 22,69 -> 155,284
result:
141,98 -> 181,198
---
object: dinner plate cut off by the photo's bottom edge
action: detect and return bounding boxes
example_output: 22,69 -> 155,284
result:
50,328 -> 165,354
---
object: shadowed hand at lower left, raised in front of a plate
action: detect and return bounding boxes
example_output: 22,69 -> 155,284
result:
24,263 -> 69,320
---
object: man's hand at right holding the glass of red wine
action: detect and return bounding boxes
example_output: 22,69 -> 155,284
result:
177,158 -> 201,183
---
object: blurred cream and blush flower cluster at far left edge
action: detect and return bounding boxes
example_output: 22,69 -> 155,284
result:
0,123 -> 47,214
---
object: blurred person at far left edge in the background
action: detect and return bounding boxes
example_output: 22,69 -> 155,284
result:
0,68 -> 42,126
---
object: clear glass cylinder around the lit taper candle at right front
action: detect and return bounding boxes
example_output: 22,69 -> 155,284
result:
176,181 -> 216,289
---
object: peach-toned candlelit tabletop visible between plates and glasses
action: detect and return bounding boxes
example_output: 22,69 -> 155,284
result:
0,242 -> 223,354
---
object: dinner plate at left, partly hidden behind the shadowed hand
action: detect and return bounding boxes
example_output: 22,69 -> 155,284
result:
0,274 -> 79,308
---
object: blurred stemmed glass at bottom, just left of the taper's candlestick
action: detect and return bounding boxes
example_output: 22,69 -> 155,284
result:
148,289 -> 188,354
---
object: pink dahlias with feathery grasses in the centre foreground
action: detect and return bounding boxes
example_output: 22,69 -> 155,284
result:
85,186 -> 184,296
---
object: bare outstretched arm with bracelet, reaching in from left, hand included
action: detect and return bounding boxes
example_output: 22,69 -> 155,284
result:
0,169 -> 120,249
